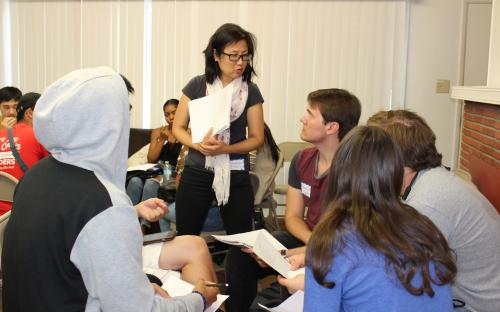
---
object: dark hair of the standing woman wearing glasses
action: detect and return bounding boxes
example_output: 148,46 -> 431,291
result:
203,23 -> 256,83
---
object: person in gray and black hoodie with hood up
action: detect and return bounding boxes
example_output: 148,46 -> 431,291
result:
2,67 -> 215,312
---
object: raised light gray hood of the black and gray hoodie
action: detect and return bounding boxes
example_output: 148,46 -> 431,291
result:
33,67 -> 130,191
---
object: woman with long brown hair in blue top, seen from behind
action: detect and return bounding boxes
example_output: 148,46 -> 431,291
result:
304,127 -> 457,312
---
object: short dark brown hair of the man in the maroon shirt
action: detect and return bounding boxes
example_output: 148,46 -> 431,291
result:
307,88 -> 361,140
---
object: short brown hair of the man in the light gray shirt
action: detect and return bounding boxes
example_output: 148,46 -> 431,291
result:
367,110 -> 443,171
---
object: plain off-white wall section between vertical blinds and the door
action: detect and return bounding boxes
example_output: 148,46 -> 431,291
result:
405,0 -> 462,166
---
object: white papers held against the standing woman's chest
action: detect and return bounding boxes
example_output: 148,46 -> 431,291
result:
188,83 -> 233,143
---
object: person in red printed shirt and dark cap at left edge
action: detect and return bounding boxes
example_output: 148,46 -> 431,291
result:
0,92 -> 48,215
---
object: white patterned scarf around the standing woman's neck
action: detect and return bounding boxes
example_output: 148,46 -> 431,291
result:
205,77 -> 248,205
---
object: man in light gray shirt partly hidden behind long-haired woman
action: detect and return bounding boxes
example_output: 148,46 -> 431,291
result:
368,110 -> 500,312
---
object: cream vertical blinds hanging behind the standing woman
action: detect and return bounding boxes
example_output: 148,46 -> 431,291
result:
0,0 -> 407,142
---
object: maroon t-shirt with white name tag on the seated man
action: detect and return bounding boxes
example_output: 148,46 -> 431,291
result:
288,147 -> 330,230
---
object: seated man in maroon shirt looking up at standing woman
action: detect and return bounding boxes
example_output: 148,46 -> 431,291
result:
226,89 -> 361,312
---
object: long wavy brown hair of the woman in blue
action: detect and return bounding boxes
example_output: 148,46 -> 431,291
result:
307,126 -> 457,297
